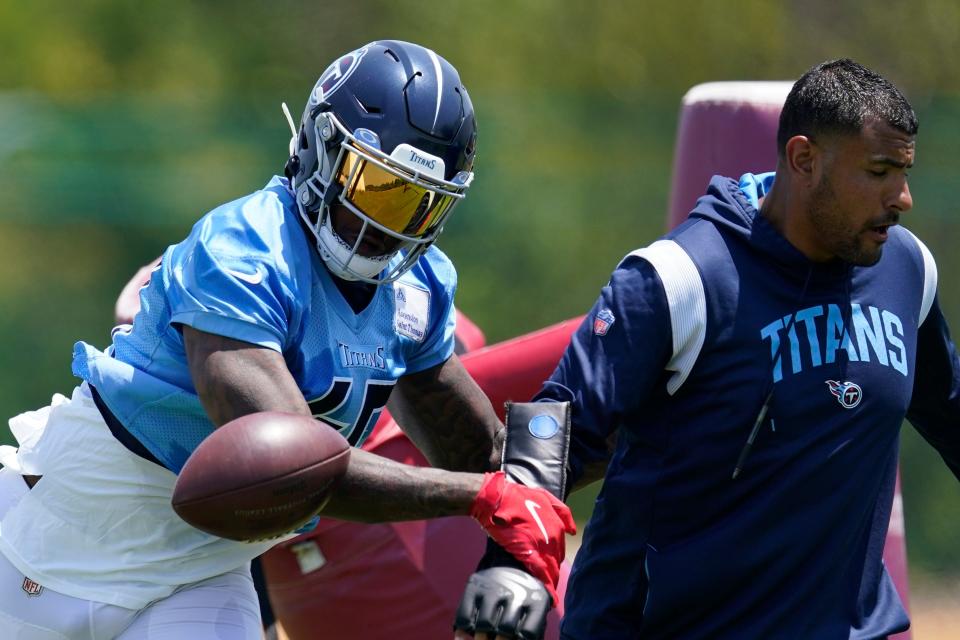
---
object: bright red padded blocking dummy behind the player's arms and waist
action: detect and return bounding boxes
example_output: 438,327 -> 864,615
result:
114,258 -> 576,640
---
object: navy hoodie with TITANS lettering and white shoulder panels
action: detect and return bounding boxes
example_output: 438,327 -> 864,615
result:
538,174 -> 960,640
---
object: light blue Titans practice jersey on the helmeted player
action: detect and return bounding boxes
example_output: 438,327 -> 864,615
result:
73,177 -> 456,472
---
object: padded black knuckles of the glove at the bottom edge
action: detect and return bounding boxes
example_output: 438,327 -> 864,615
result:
454,567 -> 553,640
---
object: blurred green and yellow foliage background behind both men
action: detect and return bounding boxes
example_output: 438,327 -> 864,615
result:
0,0 -> 960,580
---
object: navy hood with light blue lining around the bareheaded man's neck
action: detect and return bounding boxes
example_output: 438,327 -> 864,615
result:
688,172 -> 850,278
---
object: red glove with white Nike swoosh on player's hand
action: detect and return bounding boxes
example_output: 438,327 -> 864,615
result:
470,471 -> 577,603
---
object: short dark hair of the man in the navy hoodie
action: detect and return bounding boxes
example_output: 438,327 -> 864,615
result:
777,58 -> 918,157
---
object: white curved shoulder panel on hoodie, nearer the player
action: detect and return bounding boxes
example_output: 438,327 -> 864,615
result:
630,240 -> 707,395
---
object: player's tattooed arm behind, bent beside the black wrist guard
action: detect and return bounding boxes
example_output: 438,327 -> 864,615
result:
388,355 -> 504,471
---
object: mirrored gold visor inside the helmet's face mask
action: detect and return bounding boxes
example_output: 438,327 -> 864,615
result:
337,146 -> 462,238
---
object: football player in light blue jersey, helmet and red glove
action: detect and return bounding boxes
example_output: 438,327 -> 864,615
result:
0,41 -> 573,639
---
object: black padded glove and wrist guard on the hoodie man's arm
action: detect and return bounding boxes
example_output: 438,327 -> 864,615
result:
453,402 -> 570,640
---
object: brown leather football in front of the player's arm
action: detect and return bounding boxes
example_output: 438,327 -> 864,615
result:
171,412 -> 350,541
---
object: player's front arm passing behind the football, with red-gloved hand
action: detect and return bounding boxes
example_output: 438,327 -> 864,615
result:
183,326 -> 574,586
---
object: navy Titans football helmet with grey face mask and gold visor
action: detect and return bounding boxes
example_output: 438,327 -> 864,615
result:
286,40 -> 477,284
